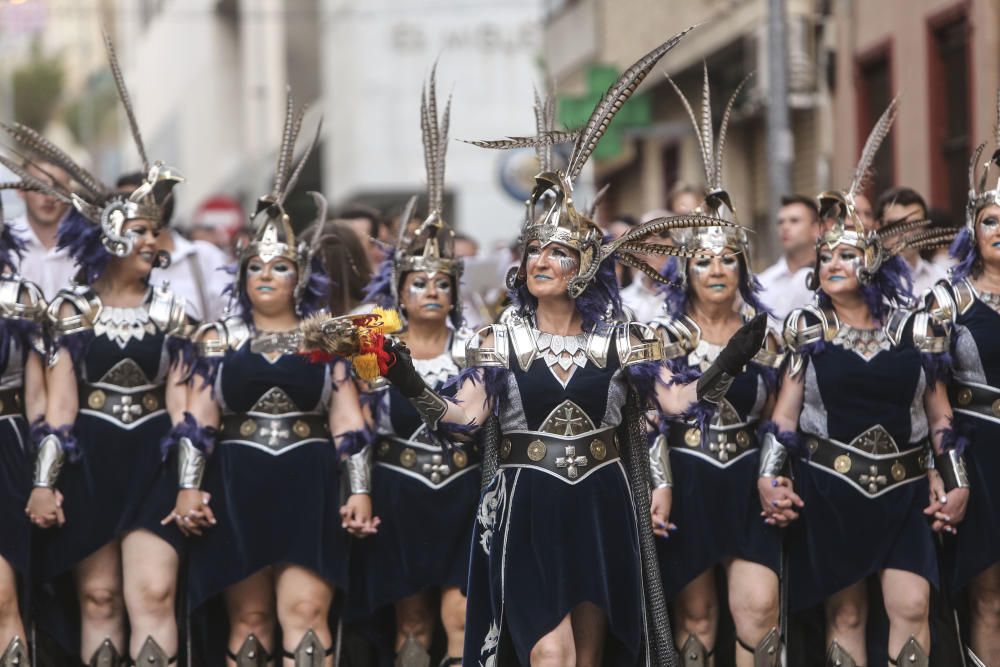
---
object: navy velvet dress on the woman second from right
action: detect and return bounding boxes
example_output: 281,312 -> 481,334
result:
786,309 -> 938,610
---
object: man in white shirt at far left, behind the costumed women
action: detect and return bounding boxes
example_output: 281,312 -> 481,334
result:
8,161 -> 76,300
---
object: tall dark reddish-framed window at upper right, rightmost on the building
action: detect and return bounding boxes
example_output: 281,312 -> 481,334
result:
927,16 -> 972,222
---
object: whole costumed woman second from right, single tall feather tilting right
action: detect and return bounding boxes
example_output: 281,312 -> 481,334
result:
758,100 -> 968,666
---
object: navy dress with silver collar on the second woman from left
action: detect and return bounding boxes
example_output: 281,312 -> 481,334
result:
38,288 -> 186,580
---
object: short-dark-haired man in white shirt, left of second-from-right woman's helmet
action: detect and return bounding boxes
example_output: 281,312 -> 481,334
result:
757,195 -> 820,326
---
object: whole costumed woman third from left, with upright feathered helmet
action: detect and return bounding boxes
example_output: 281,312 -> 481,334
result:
170,95 -> 374,667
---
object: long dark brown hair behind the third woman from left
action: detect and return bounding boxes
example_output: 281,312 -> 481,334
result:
302,220 -> 372,315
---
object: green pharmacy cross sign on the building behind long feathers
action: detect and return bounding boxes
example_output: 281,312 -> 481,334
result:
558,65 -> 652,160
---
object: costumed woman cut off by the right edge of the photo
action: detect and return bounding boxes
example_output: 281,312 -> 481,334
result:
929,91 -> 1000,665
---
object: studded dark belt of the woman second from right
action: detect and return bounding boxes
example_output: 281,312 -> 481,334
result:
804,433 -> 929,497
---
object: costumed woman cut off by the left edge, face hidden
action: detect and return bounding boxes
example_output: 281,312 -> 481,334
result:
0,183 -> 47,667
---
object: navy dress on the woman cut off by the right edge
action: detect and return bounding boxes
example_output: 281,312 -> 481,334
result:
935,281 -> 1000,591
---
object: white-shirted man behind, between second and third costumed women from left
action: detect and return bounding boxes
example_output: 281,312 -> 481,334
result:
115,171 -> 232,322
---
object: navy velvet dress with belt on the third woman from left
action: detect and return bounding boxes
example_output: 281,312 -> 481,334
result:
189,328 -> 347,612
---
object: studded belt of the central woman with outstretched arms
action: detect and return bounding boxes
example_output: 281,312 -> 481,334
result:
500,426 -> 619,482
